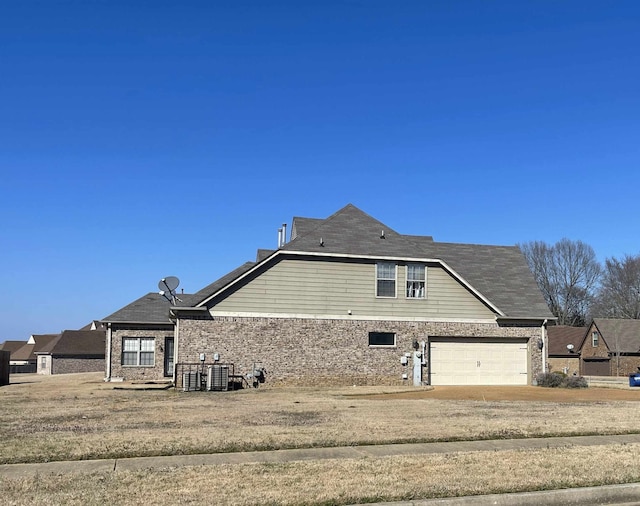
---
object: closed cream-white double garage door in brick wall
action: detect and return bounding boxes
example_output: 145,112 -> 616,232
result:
429,339 -> 528,385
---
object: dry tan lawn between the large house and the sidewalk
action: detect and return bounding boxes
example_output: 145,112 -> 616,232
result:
0,373 -> 640,463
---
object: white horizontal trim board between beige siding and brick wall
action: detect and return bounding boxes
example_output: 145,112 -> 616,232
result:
209,310 -> 496,325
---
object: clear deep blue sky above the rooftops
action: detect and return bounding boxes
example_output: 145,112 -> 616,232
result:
0,0 -> 640,342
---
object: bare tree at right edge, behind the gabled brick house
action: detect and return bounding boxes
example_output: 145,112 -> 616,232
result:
594,255 -> 640,320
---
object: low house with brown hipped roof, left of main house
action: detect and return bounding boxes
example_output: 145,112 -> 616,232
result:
34,330 -> 105,374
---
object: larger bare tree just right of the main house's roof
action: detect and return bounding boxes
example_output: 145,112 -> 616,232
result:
519,239 -> 602,326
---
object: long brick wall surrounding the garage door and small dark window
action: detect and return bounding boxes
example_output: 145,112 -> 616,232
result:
177,317 -> 542,386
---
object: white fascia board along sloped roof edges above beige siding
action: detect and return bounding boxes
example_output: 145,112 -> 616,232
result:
195,250 -> 505,316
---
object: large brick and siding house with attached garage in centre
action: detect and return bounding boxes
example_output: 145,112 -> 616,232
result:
102,205 -> 553,385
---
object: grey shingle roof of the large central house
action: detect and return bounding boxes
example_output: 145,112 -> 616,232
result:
102,204 -> 553,323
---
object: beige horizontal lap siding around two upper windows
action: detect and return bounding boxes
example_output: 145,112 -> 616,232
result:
211,259 -> 495,318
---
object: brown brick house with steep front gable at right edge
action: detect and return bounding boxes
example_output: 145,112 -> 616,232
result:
580,318 -> 640,376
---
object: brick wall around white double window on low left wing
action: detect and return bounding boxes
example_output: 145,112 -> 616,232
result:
111,326 -> 173,381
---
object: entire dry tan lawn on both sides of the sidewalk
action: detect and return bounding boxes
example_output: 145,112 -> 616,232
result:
0,374 -> 640,505
